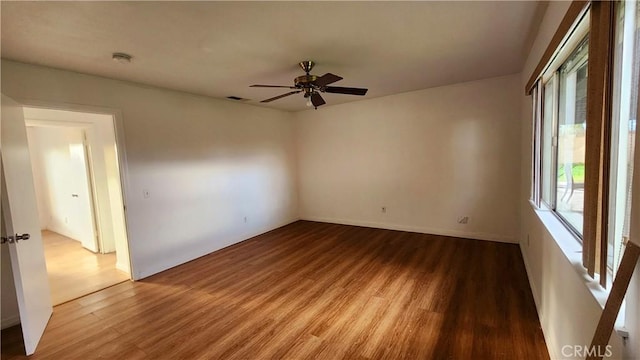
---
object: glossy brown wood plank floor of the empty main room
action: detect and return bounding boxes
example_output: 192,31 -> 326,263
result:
2,221 -> 549,360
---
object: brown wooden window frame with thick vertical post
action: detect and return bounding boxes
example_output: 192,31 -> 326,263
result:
525,1 -> 616,287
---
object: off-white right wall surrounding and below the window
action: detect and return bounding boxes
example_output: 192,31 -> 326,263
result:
518,2 -> 639,359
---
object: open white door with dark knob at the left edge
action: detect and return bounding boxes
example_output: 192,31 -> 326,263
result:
0,95 -> 53,355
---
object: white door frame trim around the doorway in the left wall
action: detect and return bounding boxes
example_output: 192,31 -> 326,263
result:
14,98 -> 139,281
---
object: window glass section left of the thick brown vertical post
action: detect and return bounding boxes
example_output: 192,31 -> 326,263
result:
539,31 -> 589,239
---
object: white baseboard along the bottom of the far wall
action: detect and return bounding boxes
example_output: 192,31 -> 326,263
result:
300,216 -> 517,244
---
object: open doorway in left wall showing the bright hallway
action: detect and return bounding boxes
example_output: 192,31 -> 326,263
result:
24,107 -> 131,305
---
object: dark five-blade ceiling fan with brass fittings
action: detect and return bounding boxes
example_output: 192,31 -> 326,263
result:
251,60 -> 368,109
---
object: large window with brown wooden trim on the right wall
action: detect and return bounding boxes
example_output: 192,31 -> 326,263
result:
526,1 -> 640,286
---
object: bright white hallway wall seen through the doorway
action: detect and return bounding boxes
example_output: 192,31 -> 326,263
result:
27,126 -> 98,252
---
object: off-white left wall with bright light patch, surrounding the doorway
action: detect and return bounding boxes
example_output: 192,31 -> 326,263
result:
2,60 -> 297,279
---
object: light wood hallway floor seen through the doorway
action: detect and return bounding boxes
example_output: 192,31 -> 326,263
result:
42,230 -> 129,305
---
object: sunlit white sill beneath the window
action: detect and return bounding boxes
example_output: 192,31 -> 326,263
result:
530,202 -> 624,328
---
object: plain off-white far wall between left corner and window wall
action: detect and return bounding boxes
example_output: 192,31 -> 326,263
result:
295,75 -> 522,242
